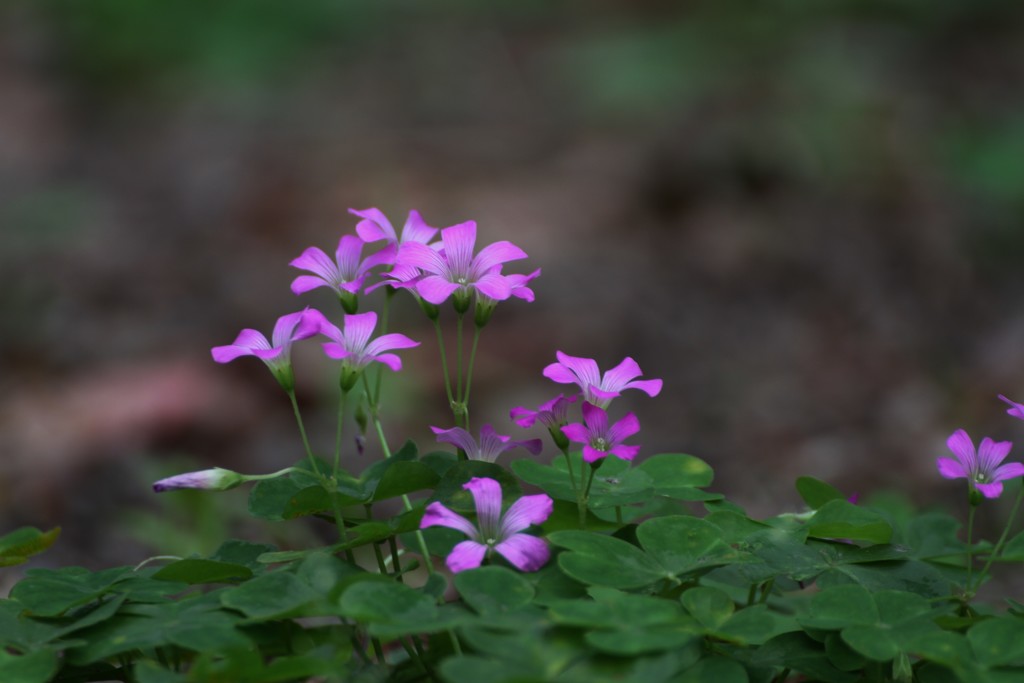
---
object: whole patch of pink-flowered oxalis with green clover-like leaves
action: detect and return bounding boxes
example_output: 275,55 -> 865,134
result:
0,209 -> 1024,683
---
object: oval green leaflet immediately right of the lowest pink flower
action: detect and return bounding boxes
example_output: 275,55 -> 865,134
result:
548,531 -> 675,589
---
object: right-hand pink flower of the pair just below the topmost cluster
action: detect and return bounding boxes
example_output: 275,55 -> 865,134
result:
316,311 -> 420,389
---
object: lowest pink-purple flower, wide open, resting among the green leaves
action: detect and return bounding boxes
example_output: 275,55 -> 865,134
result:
420,477 -> 554,572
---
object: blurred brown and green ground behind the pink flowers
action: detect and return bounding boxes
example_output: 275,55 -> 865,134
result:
0,0 -> 1024,567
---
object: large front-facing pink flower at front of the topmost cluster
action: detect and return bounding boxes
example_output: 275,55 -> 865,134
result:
387,221 -> 526,306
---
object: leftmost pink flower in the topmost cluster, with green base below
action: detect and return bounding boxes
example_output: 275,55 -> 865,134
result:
289,234 -> 397,313
